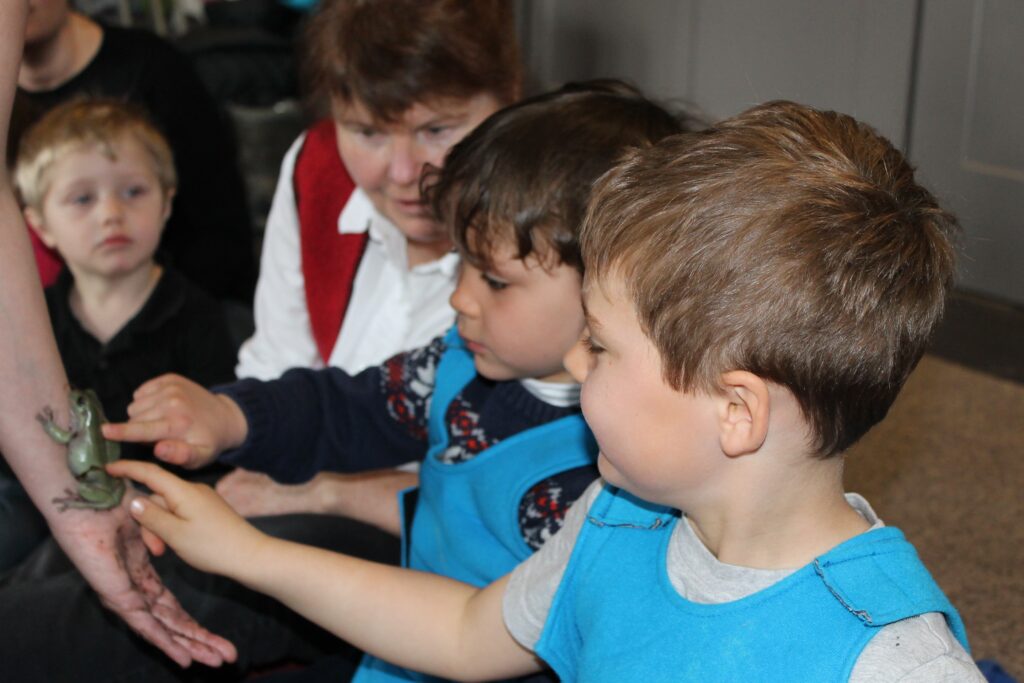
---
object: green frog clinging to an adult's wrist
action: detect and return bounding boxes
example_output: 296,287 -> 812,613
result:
36,389 -> 125,512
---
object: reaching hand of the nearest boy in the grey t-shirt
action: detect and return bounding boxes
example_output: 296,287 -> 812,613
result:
108,460 -> 268,579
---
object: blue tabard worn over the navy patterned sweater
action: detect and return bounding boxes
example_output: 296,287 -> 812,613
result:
352,328 -> 597,683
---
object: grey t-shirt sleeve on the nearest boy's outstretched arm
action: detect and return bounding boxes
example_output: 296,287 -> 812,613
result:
502,479 -> 604,650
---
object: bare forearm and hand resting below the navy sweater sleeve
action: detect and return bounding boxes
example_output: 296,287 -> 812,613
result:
216,469 -> 411,536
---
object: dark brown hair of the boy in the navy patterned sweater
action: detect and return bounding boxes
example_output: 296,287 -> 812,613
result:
423,79 -> 697,271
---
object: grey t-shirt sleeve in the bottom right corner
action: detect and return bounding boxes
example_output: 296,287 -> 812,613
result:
850,612 -> 985,683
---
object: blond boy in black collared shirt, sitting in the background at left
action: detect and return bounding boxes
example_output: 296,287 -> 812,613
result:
0,98 -> 236,569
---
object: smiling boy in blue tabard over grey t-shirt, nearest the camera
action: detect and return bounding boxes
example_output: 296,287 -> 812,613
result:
110,102 -> 984,682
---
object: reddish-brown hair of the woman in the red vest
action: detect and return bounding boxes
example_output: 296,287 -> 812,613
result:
305,0 -> 522,121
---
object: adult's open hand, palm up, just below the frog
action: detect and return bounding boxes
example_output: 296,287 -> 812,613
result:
51,502 -> 238,667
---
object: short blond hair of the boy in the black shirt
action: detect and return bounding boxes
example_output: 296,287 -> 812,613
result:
14,98 -> 178,209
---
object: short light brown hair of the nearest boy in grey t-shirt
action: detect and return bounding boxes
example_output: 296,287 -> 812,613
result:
582,102 -> 957,457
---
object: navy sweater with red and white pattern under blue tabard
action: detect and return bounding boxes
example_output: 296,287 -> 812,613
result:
216,338 -> 598,549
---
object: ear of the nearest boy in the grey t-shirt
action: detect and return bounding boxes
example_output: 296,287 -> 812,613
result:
719,370 -> 771,458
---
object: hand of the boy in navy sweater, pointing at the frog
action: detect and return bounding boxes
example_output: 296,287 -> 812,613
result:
103,375 -> 249,468
